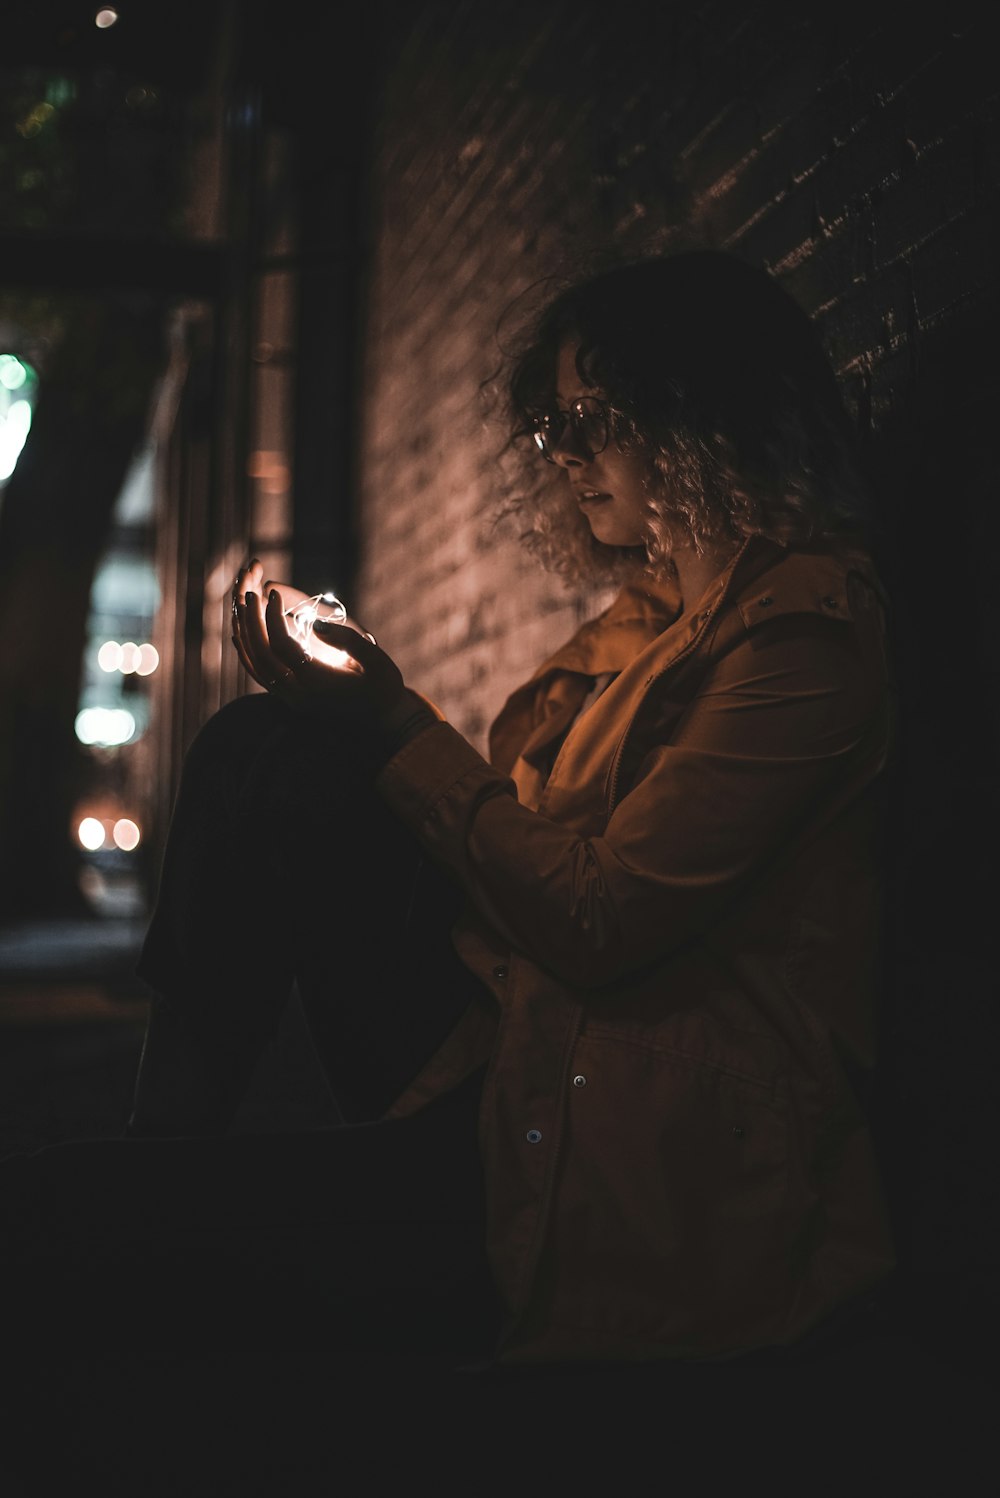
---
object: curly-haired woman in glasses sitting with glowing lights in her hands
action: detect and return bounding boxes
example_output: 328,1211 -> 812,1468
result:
3,253 -> 892,1363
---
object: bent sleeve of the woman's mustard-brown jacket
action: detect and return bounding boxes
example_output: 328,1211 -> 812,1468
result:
377,617 -> 885,987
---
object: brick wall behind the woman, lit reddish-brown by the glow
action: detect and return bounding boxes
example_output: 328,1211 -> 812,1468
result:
352,0 -> 997,742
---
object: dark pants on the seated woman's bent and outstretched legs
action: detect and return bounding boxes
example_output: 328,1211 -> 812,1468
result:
0,697 -> 499,1357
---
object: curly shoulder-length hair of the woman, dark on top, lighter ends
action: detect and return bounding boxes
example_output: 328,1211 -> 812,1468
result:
488,250 -> 868,583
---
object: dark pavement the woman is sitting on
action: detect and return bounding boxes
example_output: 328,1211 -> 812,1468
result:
0,917 -> 1000,1498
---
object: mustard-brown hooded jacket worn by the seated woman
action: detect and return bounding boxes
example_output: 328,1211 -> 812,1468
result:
379,541 -> 892,1360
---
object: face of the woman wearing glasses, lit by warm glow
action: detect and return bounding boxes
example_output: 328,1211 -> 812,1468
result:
552,339 -> 648,547
